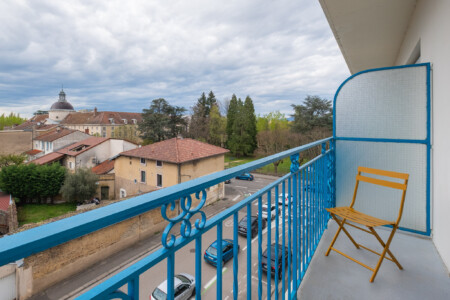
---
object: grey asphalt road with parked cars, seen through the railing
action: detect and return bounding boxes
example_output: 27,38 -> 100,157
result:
140,175 -> 298,300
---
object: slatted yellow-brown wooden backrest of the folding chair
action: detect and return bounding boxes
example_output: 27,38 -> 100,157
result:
350,167 -> 409,225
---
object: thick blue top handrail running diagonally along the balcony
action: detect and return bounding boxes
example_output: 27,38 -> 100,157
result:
0,138 -> 331,265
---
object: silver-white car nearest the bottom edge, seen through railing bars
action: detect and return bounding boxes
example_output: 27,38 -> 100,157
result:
150,273 -> 195,300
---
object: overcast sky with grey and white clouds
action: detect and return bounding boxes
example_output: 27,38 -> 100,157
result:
0,0 -> 350,117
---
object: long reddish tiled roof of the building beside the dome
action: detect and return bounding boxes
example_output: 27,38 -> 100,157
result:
61,111 -> 142,125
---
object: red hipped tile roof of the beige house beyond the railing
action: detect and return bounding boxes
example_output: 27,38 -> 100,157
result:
120,138 -> 229,163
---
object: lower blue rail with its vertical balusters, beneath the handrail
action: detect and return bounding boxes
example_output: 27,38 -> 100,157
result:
78,146 -> 330,299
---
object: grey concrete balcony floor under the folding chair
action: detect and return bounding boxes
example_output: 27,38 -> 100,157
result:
298,221 -> 450,300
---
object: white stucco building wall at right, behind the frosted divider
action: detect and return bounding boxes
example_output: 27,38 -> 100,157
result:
396,0 -> 450,270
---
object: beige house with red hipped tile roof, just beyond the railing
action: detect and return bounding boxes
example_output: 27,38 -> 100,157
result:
114,138 -> 228,202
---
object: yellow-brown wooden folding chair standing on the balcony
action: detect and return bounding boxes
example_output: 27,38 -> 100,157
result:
325,167 -> 409,282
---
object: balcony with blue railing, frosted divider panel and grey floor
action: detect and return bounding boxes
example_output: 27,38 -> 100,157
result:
0,64 -> 450,299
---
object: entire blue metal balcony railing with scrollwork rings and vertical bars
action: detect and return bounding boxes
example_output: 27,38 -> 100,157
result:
0,138 -> 335,299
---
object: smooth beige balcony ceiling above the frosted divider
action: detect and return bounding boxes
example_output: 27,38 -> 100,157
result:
319,0 -> 417,74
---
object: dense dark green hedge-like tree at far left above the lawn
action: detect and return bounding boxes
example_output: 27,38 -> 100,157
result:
0,163 -> 66,202
